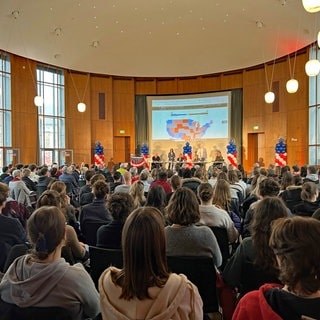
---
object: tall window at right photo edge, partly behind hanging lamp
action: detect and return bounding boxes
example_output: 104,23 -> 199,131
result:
309,45 -> 320,165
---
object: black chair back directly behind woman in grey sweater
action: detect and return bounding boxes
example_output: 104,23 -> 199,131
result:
167,256 -> 219,314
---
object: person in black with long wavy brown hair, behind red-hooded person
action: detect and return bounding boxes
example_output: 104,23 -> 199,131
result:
223,197 -> 288,296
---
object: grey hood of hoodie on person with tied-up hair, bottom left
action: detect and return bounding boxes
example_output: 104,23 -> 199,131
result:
0,255 -> 69,308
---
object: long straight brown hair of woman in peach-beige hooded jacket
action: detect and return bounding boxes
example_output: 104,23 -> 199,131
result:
111,207 -> 169,300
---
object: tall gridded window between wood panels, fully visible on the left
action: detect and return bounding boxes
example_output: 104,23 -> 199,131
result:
37,66 -> 65,165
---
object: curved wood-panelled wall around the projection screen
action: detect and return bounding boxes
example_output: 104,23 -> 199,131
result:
11,50 -> 308,170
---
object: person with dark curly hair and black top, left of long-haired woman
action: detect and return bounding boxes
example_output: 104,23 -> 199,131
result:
97,192 -> 133,249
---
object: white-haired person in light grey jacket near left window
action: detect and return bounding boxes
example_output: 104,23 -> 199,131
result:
9,169 -> 31,208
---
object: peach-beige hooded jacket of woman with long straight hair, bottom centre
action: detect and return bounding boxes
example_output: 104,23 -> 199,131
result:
99,267 -> 201,320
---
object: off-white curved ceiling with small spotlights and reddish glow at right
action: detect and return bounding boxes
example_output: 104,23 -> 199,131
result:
0,0 -> 320,77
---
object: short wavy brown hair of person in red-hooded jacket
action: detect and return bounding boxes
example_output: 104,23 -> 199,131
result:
269,216 -> 320,296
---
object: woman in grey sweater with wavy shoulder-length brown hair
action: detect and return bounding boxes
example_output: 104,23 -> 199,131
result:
165,187 -> 222,267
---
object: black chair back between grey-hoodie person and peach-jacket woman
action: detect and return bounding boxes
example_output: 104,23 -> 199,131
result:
89,246 -> 123,287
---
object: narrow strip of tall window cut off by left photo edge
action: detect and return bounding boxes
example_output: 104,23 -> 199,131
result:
0,52 -> 12,167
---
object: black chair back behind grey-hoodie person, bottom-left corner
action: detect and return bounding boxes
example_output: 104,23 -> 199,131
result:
0,299 -> 72,320
